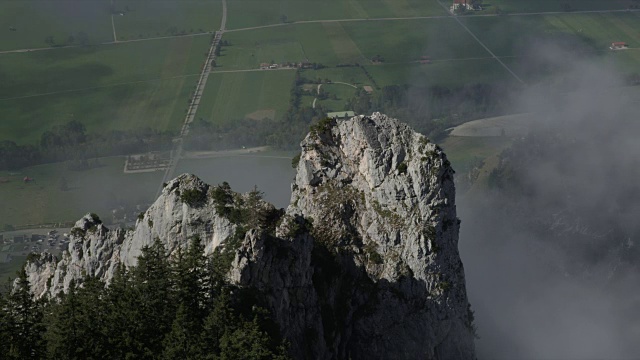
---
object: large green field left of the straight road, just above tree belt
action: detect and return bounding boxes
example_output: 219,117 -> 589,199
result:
0,36 -> 209,143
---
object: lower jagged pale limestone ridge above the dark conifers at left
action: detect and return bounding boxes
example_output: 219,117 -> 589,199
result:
27,174 -> 236,296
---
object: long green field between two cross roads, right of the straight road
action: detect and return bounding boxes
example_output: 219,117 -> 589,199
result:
218,18 -> 487,70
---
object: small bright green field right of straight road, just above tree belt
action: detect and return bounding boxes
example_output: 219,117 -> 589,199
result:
196,70 -> 295,124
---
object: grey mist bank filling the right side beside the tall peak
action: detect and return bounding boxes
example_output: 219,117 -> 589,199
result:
458,44 -> 640,359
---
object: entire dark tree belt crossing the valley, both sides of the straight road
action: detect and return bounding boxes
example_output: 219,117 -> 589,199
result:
0,70 -> 513,170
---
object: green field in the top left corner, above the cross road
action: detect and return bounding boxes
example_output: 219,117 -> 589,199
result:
0,0 -> 113,51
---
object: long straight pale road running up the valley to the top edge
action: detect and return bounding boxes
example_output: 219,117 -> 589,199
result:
156,0 -> 227,197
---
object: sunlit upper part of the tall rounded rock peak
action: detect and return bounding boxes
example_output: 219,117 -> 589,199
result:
287,113 -> 464,287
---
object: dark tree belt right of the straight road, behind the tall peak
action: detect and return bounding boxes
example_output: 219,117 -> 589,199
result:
185,69 -> 513,150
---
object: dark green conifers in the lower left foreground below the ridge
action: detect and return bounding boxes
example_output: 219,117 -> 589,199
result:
0,237 -> 288,359
